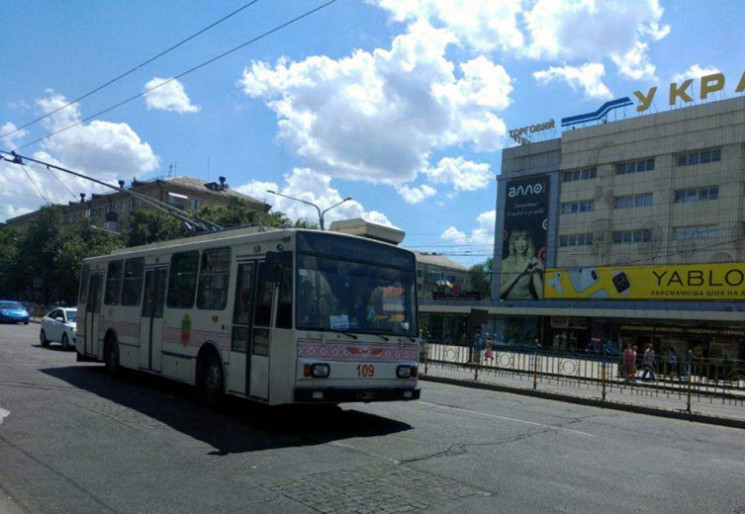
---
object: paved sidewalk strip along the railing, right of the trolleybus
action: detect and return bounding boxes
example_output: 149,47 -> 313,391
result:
419,363 -> 745,429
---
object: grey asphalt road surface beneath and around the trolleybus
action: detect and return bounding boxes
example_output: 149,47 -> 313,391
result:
0,324 -> 745,514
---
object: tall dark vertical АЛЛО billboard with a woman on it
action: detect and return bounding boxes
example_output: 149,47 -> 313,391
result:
499,175 -> 549,300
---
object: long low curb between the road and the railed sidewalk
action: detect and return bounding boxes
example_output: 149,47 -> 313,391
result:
419,375 -> 745,430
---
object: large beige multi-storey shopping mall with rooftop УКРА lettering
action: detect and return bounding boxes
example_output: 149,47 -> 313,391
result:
422,88 -> 745,359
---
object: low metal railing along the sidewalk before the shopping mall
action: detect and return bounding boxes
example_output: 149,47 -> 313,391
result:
422,343 -> 745,412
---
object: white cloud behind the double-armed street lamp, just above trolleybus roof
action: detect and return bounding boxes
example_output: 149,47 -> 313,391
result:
234,168 -> 393,228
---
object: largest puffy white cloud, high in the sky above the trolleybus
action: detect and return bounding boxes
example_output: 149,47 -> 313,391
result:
239,21 -> 512,184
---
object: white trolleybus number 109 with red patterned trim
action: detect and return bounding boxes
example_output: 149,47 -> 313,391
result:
76,222 -> 420,405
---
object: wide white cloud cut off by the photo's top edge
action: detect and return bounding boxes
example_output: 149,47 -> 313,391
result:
368,0 -> 670,79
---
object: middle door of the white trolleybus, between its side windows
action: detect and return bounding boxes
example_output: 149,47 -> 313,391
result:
140,267 -> 168,372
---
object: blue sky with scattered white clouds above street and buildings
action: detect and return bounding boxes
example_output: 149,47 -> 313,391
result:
0,0 -> 745,266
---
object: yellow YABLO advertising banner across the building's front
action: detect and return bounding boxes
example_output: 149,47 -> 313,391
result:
543,262 -> 745,301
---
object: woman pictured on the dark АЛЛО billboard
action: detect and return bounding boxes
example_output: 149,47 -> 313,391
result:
500,230 -> 543,300
